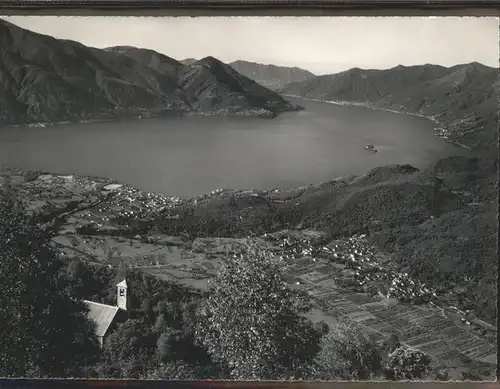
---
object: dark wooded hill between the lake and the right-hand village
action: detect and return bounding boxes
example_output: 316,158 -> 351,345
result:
154,157 -> 497,323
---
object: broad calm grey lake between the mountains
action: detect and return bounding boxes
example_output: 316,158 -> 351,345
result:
0,99 -> 466,196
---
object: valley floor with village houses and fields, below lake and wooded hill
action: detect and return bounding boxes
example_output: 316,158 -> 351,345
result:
0,167 -> 497,378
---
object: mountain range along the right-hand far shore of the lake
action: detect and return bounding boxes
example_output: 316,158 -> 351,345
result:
280,62 -> 500,160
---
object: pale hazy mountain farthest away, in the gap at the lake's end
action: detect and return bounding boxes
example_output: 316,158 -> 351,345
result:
229,61 -> 315,90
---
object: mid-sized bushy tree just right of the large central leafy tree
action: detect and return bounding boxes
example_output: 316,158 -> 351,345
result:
315,321 -> 381,380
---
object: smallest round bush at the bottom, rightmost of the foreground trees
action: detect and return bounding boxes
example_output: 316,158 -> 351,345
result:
386,346 -> 431,380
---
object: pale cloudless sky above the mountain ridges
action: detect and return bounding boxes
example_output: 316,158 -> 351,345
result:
4,16 -> 499,75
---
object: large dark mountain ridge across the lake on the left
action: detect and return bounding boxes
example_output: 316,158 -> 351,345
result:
0,20 -> 296,124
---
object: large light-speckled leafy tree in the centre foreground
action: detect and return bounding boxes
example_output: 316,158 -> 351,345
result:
195,245 -> 320,379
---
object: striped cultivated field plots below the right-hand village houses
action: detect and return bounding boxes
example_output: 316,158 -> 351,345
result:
286,261 -> 497,373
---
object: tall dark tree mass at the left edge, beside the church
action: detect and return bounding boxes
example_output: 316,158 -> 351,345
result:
0,183 -> 99,377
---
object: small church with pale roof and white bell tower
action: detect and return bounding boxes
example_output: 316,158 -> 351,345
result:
84,280 -> 128,347
